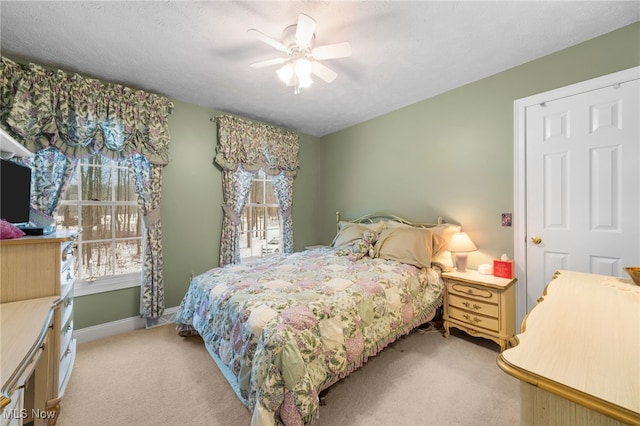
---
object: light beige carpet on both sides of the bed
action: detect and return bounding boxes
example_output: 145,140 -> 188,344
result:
58,324 -> 520,426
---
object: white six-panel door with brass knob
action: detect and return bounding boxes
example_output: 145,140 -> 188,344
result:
516,68 -> 640,326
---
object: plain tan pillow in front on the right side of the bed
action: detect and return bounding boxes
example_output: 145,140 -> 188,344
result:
374,226 -> 434,268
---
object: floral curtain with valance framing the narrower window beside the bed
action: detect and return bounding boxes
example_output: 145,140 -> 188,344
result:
214,115 -> 298,266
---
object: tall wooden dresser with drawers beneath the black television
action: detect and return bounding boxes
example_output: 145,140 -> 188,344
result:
0,231 -> 77,424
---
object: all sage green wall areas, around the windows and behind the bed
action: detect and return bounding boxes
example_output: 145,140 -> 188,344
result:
75,23 -> 640,329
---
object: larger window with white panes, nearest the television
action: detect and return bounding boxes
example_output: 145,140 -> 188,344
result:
56,154 -> 144,295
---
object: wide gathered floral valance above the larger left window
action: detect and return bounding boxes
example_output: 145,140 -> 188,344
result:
0,57 -> 173,165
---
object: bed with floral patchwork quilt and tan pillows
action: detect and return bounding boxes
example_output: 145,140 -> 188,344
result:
176,214 -> 460,425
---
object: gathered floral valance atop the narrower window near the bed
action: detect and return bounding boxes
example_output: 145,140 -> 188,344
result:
215,115 -> 298,176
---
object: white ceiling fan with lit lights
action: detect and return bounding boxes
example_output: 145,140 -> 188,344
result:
248,13 -> 351,94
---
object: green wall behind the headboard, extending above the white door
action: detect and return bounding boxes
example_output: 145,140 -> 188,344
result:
319,23 -> 640,267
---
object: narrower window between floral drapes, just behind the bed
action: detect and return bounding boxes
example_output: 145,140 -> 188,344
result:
240,170 -> 280,259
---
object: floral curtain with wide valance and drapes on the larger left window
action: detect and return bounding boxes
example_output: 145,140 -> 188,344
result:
0,57 -> 173,318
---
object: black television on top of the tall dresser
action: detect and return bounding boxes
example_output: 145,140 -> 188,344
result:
0,159 -> 31,224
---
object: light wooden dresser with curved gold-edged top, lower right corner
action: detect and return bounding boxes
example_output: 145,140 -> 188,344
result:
498,271 -> 640,426
